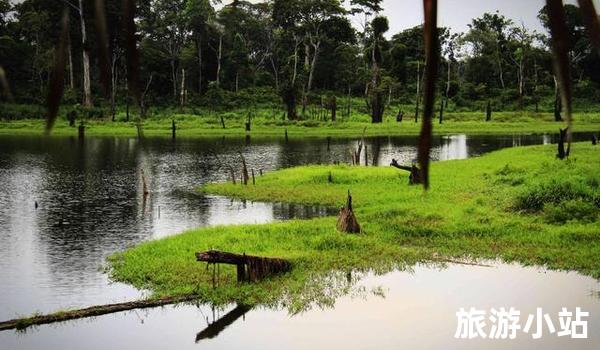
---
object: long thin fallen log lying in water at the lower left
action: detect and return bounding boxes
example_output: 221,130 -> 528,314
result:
0,295 -> 198,331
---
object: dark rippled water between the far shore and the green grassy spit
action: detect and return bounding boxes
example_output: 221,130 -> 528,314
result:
0,135 -> 588,348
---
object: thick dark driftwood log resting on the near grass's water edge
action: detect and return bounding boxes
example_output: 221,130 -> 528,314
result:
196,250 -> 292,282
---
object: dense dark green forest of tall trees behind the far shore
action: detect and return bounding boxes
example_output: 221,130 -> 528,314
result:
0,0 -> 600,122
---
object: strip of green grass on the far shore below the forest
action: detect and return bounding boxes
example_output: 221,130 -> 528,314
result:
0,111 -> 600,137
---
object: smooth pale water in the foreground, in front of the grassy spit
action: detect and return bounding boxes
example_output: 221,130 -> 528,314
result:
0,263 -> 600,350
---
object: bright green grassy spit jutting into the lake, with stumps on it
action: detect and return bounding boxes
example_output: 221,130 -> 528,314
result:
110,144 -> 600,310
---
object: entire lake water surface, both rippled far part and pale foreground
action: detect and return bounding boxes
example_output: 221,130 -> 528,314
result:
0,134 -> 600,349
